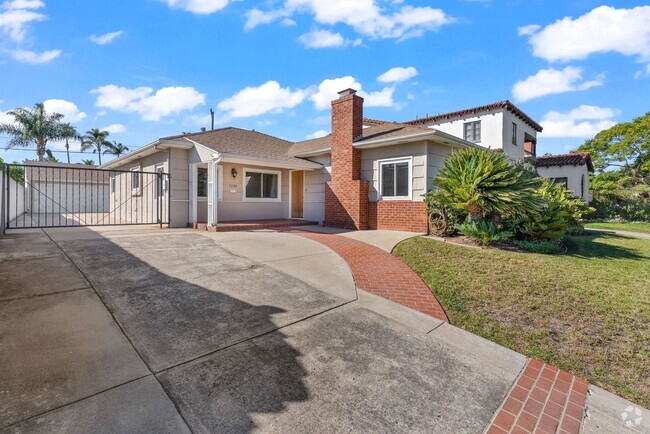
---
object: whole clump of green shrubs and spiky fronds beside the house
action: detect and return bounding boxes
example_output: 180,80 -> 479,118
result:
425,148 -> 591,245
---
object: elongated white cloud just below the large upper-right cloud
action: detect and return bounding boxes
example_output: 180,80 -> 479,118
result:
512,66 -> 604,101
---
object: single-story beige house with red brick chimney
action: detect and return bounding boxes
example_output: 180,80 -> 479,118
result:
102,89 -> 478,232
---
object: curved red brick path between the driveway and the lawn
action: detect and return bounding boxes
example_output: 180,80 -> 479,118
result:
289,230 -> 449,322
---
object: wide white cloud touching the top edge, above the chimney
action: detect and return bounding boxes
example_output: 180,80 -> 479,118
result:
244,0 -> 454,39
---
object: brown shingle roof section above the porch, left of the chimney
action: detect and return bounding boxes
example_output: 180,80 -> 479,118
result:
161,127 -> 312,163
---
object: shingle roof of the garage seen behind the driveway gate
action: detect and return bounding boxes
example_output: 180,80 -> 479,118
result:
25,160 -> 110,184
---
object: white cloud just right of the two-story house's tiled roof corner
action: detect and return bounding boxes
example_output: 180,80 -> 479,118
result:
540,105 -> 618,138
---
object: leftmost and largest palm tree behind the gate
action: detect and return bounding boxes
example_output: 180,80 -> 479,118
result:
0,103 -> 63,161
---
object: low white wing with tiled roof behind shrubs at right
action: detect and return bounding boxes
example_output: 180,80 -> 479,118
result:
532,152 -> 594,203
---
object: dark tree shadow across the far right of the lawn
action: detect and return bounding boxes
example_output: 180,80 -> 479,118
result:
564,232 -> 648,260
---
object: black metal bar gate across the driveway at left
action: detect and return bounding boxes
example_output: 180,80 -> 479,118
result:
0,164 -> 171,229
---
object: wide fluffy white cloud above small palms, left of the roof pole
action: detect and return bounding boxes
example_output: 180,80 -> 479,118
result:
91,84 -> 205,121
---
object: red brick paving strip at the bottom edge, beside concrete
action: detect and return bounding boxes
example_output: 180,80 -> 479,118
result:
487,359 -> 587,434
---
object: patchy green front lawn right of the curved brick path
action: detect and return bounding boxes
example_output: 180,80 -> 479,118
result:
394,234 -> 650,408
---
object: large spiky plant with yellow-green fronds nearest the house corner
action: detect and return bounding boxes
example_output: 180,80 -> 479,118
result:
433,148 -> 544,221
